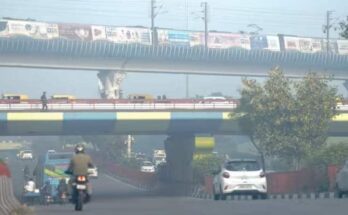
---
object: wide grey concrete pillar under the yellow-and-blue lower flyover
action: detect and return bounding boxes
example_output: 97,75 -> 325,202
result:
164,134 -> 195,183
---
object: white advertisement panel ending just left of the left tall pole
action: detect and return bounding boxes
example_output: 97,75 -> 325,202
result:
105,26 -> 151,45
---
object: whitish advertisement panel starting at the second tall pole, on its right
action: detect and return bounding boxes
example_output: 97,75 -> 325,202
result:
208,32 -> 250,49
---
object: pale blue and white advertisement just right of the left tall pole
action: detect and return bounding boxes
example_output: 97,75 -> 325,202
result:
157,29 -> 190,46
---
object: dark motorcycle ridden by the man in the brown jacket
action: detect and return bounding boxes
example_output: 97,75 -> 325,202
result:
72,175 -> 89,211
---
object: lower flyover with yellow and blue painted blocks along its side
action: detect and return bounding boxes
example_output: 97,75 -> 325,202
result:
0,100 -> 348,136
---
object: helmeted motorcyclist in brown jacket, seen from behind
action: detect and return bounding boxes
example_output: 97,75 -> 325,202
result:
65,144 -> 94,201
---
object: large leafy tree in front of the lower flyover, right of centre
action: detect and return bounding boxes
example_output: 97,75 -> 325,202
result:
237,68 -> 337,168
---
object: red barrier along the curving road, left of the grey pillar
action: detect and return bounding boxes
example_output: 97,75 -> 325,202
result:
106,163 -> 158,190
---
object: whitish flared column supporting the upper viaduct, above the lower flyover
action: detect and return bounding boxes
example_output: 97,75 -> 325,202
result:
98,70 -> 126,99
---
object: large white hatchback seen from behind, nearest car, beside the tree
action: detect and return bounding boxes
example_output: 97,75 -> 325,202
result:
213,159 -> 267,200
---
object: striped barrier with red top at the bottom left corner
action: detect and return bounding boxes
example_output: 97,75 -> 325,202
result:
0,163 -> 21,215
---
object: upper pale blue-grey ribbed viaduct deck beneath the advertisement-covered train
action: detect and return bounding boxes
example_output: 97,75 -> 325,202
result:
0,37 -> 348,79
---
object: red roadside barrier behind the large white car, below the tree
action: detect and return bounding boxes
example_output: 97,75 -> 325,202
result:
200,165 -> 339,195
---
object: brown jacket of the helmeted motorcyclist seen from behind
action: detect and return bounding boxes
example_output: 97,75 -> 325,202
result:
68,153 -> 93,175
